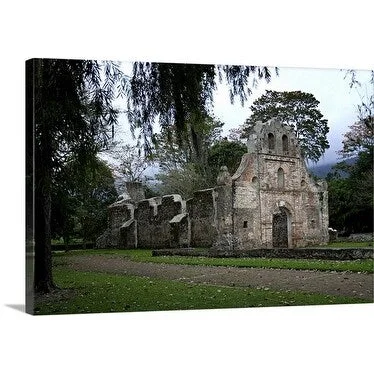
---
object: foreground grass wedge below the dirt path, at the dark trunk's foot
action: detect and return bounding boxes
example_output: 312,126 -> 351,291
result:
35,262 -> 370,315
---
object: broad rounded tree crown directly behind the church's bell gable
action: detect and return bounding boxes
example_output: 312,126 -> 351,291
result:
243,90 -> 329,161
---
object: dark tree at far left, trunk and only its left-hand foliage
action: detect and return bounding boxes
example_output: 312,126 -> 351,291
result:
26,59 -> 123,292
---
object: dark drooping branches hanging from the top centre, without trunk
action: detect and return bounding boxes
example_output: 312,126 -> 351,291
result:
128,62 -> 277,150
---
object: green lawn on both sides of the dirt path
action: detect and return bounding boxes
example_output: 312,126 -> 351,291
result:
35,249 -> 373,314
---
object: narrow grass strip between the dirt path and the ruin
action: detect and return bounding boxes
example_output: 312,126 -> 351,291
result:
57,249 -> 374,273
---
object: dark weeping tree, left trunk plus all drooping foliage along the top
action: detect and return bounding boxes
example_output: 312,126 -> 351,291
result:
26,59 -> 271,292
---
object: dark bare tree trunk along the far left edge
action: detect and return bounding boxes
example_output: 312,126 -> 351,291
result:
26,60 -> 55,293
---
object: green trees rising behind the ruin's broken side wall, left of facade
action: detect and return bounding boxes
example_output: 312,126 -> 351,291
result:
152,117 -> 247,199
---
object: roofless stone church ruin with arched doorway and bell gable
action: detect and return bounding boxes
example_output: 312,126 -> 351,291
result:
97,119 -> 328,250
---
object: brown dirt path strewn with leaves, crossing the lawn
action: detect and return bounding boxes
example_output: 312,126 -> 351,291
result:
65,256 -> 373,301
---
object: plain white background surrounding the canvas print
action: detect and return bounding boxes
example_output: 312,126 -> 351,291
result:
0,0 -> 374,373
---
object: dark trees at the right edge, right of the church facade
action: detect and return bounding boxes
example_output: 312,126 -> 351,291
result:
328,70 -> 374,233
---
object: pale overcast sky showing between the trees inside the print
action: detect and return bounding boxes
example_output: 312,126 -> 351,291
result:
116,62 -> 373,164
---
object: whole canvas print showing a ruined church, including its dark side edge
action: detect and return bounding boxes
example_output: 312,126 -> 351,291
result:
26,59 -> 374,315
